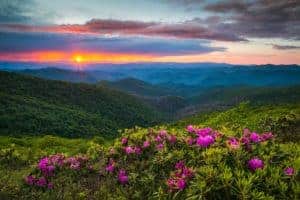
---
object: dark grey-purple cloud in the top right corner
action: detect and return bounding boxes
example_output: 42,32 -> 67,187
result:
205,0 -> 300,40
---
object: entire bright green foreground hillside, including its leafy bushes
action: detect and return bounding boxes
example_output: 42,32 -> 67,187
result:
0,103 -> 300,200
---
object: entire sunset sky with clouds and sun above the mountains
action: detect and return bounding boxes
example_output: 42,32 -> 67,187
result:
0,0 -> 300,64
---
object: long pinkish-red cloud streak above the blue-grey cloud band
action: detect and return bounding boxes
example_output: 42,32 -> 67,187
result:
0,19 -> 245,41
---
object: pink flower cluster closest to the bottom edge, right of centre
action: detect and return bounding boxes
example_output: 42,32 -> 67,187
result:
167,161 -> 194,191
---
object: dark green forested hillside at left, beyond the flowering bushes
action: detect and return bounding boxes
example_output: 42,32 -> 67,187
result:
0,72 -> 163,137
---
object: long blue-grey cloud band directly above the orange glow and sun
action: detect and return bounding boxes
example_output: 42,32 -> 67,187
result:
0,32 -> 226,56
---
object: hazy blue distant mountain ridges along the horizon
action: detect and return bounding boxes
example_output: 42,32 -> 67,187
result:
0,63 -> 300,91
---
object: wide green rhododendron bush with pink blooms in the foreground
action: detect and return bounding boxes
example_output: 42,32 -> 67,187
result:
18,125 -> 299,199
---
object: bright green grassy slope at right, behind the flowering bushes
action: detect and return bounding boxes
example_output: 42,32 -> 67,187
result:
175,102 -> 300,141
